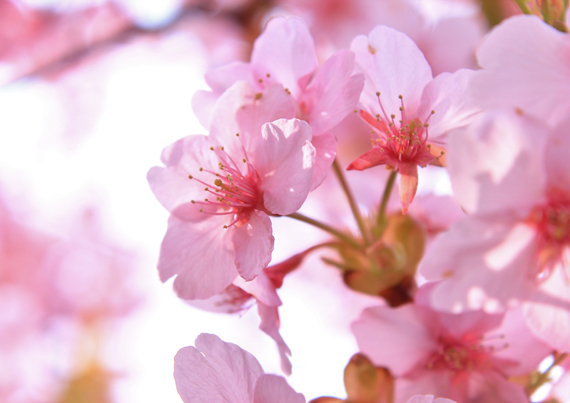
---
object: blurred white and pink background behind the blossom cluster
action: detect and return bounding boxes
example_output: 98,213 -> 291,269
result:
0,0 -> 528,403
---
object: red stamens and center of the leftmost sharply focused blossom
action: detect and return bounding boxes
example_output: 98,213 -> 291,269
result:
188,138 -> 259,228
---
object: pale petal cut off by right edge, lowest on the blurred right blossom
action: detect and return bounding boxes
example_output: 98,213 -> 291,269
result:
523,264 -> 570,352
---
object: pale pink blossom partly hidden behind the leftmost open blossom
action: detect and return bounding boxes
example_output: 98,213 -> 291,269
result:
192,17 -> 363,189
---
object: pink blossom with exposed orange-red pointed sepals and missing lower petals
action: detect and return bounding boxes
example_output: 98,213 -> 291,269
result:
347,26 -> 478,214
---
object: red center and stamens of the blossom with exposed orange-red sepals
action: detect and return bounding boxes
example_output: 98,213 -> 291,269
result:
360,92 -> 443,166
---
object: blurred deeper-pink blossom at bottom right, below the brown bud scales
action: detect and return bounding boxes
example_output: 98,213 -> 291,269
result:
352,285 -> 551,403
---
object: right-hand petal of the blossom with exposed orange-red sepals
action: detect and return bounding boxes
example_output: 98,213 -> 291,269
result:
412,70 -> 481,145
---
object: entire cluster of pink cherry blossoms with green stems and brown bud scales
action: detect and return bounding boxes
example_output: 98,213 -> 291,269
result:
148,1 -> 570,403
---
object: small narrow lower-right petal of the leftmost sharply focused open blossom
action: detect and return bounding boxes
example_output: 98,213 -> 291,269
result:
232,210 -> 275,281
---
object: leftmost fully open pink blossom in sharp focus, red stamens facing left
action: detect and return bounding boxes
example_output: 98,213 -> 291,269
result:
148,82 -> 315,299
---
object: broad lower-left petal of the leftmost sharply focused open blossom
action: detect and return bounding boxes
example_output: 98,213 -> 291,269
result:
158,216 -> 238,299
